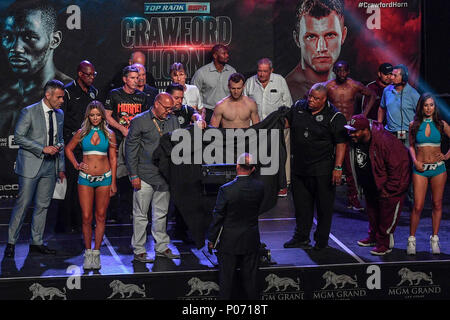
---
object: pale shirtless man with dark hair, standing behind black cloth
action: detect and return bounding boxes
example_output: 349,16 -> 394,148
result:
211,73 -> 259,128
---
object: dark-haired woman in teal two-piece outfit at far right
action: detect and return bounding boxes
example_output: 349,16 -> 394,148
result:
406,93 -> 450,255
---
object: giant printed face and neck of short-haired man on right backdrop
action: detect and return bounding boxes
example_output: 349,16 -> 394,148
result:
286,0 -> 347,101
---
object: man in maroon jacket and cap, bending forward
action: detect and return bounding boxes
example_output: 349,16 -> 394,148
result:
345,114 -> 411,256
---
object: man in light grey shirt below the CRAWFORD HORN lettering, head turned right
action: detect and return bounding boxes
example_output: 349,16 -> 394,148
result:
191,44 -> 237,124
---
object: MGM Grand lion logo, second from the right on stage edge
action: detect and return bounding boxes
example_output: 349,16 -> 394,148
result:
313,270 -> 367,300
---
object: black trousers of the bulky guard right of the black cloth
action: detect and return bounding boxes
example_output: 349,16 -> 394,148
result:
291,173 -> 336,246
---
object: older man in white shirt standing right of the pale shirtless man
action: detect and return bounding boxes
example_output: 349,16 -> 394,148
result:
244,58 -> 292,197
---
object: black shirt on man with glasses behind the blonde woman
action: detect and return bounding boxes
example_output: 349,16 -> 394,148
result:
61,80 -> 98,144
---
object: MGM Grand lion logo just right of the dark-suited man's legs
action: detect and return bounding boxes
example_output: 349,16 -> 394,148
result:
261,273 -> 305,300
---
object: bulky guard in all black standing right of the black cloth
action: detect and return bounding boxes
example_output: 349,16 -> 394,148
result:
284,83 -> 347,250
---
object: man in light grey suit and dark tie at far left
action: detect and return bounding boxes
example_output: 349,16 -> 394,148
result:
5,80 -> 65,258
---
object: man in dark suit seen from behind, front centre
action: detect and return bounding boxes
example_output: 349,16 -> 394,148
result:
208,153 -> 264,300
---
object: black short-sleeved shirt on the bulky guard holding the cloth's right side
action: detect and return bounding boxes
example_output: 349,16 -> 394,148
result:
286,100 -> 347,176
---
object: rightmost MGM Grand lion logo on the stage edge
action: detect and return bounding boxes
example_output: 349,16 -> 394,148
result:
389,267 -> 442,299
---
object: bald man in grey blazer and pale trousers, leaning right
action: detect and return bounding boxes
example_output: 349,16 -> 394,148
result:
125,92 -> 180,263
